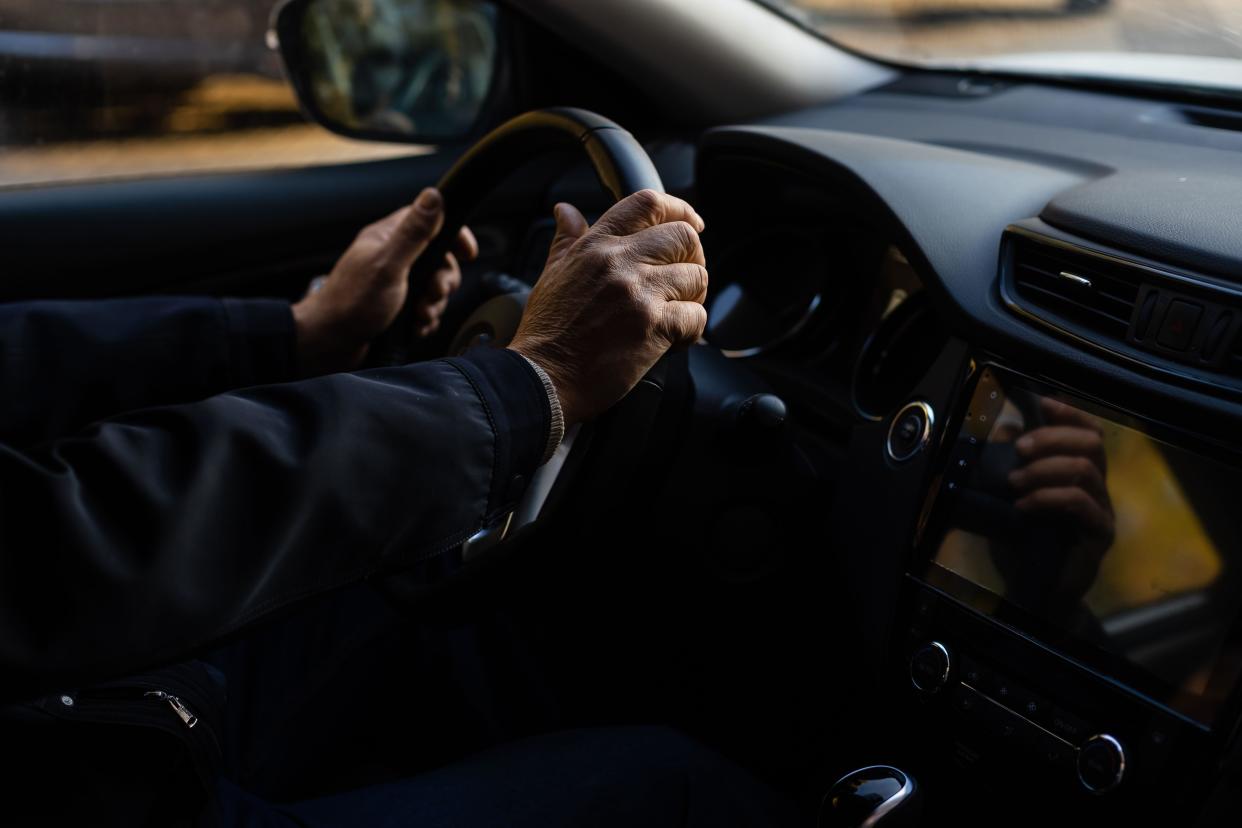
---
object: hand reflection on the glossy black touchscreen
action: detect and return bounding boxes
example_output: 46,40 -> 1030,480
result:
1009,398 -> 1114,598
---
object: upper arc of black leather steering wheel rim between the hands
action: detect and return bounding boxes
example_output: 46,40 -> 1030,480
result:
369,107 -> 664,365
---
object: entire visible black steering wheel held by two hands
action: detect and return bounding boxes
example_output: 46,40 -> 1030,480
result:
369,108 -> 669,603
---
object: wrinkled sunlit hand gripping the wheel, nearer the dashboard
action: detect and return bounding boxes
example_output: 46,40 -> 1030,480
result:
509,190 -> 708,425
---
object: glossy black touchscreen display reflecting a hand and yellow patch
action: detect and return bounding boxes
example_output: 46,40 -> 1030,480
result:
923,367 -> 1242,724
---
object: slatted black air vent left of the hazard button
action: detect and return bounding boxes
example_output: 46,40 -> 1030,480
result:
1011,238 -> 1140,341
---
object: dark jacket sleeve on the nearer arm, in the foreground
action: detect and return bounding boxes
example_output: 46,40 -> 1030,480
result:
0,350 -> 550,700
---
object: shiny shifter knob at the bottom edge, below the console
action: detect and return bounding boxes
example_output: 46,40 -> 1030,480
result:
820,765 -> 919,828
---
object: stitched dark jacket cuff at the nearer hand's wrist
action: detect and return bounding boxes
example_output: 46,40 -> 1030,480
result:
450,348 -> 551,514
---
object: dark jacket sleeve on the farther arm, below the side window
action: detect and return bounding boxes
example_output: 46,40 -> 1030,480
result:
0,297 -> 296,446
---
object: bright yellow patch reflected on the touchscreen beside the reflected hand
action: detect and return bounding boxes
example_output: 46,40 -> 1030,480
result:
1084,422 -> 1223,618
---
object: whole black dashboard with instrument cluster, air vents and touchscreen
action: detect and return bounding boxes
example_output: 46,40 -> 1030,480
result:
697,74 -> 1242,824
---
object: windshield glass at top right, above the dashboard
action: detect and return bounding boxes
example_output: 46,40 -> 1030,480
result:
760,0 -> 1242,92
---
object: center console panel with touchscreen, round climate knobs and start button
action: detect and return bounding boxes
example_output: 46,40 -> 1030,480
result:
887,365 -> 1242,817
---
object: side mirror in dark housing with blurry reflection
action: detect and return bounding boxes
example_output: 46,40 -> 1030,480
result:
267,0 -> 499,144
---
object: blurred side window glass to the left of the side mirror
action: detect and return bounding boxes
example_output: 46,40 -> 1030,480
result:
0,0 -> 425,187
